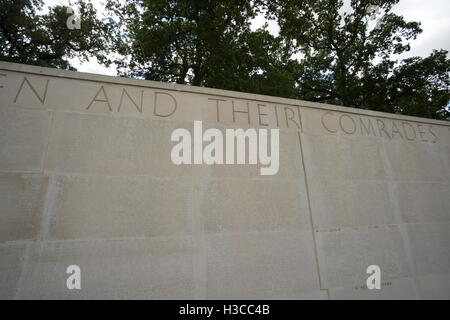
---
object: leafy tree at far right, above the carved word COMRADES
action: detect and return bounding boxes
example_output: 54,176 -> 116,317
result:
267,0 -> 450,119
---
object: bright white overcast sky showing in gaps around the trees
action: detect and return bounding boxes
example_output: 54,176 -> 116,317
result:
44,0 -> 450,75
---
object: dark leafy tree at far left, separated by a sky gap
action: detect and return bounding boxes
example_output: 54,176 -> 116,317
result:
0,0 -> 112,68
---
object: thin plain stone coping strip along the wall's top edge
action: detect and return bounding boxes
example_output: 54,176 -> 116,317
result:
0,61 -> 450,127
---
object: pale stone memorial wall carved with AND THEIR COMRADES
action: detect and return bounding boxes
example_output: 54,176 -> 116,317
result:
0,62 -> 450,299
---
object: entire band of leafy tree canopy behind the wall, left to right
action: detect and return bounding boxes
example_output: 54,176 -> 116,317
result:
0,0 -> 450,119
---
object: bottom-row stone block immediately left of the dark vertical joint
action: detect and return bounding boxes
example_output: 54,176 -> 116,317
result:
206,230 -> 320,299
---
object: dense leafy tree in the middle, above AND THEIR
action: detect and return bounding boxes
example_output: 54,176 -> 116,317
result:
108,0 -> 298,96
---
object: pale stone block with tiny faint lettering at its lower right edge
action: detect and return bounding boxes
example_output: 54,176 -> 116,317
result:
316,226 -> 411,288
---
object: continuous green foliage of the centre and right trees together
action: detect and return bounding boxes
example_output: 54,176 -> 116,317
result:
110,0 -> 450,119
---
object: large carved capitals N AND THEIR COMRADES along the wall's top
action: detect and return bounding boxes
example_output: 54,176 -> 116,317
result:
0,73 -> 450,143
